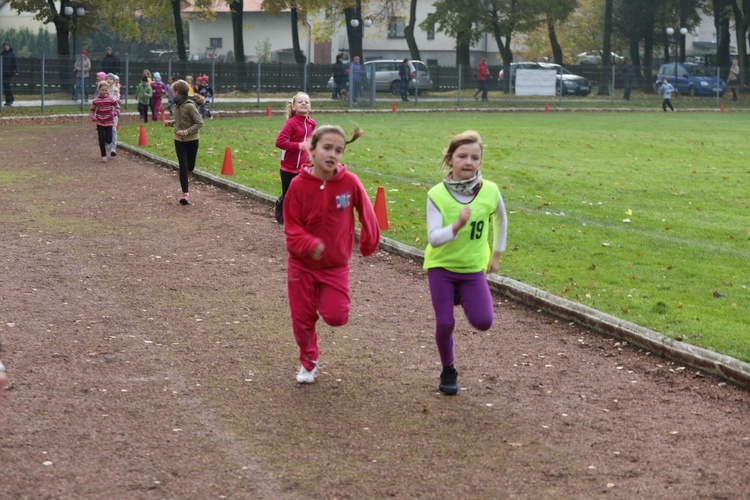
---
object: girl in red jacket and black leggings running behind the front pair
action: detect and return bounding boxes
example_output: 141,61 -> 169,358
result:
274,92 -> 315,224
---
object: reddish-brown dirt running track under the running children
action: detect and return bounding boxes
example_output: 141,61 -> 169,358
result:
0,120 -> 750,499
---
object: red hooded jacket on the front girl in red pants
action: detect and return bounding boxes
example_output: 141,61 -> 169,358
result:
284,163 -> 380,269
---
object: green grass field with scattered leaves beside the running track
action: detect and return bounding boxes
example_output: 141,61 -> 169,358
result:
120,112 -> 750,362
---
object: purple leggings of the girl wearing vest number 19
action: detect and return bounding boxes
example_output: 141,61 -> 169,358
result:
427,267 -> 494,366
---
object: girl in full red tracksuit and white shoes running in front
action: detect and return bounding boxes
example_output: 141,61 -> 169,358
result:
284,125 -> 380,384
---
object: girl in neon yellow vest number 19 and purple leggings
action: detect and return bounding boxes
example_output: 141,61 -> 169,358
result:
424,130 -> 508,395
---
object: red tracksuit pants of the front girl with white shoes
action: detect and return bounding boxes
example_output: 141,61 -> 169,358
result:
287,259 -> 352,370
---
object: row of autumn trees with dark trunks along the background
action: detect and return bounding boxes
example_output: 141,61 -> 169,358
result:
10,0 -> 750,94
